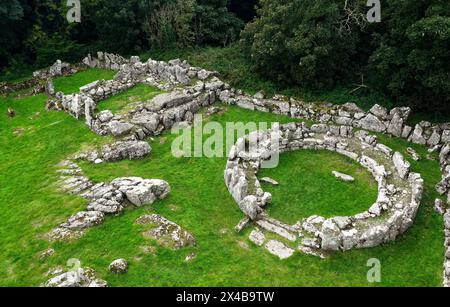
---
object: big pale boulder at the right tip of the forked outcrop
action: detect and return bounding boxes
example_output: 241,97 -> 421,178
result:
111,177 -> 170,206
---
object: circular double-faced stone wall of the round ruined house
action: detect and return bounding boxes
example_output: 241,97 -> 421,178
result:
224,123 -> 423,254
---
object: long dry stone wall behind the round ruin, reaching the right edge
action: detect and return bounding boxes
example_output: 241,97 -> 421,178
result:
214,89 -> 450,204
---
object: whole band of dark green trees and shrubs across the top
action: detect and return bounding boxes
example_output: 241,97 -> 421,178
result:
0,0 -> 450,116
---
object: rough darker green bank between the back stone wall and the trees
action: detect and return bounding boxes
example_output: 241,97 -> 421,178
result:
141,43 -> 448,124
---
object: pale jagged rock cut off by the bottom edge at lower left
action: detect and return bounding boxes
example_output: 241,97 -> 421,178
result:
43,268 -> 108,288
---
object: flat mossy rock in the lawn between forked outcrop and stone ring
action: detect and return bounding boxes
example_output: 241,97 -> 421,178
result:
136,214 -> 196,249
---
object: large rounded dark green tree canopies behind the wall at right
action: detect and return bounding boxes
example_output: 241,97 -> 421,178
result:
243,0 -> 450,114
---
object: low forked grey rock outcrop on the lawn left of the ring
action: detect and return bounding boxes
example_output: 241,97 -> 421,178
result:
46,141 -> 170,241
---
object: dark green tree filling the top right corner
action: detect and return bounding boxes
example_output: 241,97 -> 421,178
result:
368,0 -> 450,112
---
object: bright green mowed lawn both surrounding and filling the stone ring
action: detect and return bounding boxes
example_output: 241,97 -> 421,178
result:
0,74 -> 444,286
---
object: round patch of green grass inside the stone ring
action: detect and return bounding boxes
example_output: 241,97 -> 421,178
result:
259,150 -> 378,225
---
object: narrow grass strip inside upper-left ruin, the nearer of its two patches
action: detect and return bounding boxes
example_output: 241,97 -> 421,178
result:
98,84 -> 162,113
